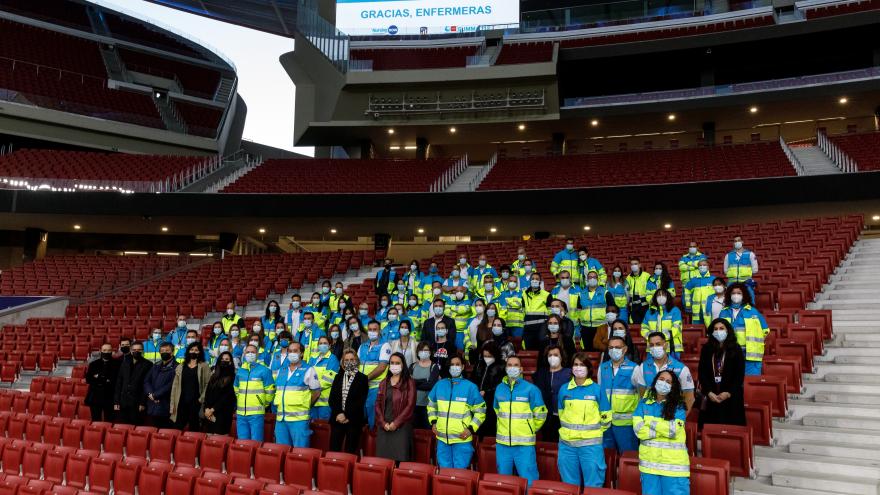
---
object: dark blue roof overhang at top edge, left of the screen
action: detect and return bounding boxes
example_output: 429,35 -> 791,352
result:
145,0 -> 297,38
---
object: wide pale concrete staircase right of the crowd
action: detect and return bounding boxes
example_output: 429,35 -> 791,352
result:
734,233 -> 880,495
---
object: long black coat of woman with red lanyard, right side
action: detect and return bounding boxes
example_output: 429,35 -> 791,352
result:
698,344 -> 746,426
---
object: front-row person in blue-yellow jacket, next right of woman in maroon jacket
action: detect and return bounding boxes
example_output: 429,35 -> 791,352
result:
428,356 -> 486,469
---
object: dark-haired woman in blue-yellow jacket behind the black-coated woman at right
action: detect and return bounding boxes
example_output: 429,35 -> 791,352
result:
718,282 -> 770,376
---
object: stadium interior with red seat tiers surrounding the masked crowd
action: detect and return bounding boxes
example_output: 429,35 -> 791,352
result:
0,0 -> 880,495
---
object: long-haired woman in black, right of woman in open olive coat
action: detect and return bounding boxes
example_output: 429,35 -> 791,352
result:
169,342 -> 211,431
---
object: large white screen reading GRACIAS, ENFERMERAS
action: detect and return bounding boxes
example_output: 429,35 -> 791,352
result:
336,0 -> 520,36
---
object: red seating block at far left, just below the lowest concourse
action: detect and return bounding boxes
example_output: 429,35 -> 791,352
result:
0,255 -> 190,297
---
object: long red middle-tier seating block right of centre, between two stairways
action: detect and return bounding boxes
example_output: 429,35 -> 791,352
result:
479,142 -> 796,191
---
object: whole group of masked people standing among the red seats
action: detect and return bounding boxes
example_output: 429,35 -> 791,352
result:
87,238 -> 769,495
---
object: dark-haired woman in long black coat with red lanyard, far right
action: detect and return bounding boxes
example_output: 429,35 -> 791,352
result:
697,318 -> 746,427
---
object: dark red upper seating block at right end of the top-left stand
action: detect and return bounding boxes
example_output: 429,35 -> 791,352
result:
119,48 -> 220,100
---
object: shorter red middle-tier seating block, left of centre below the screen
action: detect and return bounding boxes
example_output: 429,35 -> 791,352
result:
223,159 -> 454,193
